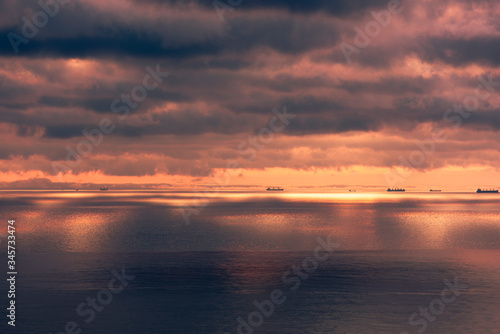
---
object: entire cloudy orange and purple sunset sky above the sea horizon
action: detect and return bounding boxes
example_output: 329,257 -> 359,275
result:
0,0 -> 500,190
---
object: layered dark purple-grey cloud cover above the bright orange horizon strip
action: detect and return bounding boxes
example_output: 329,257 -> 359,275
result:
0,0 -> 500,181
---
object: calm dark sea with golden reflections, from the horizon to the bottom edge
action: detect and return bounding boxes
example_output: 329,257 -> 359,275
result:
0,191 -> 500,334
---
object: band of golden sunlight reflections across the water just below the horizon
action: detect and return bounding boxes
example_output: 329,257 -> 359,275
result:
4,192 -> 500,251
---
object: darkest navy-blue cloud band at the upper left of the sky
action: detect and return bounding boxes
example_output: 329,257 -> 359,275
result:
0,3 -> 338,58
